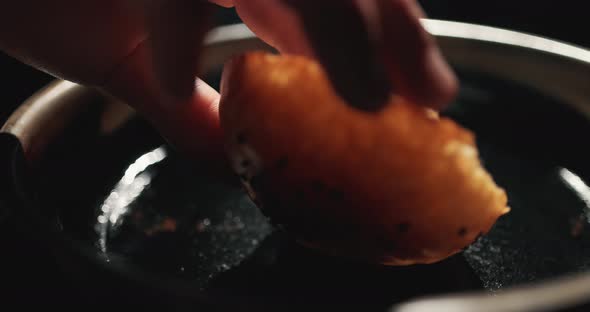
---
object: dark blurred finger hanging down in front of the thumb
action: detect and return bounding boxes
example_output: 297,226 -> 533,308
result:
146,0 -> 211,100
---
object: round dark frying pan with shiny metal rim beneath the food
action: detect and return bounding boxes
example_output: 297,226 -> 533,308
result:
0,20 -> 590,312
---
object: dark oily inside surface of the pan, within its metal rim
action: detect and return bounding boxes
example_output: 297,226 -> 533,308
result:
28,70 -> 590,311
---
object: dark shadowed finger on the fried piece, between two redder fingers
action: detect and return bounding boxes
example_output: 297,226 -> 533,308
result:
286,0 -> 392,111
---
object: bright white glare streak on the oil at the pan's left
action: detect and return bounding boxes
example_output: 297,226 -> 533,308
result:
96,147 -> 167,252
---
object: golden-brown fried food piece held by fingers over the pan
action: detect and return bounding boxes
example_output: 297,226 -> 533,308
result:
220,52 -> 509,265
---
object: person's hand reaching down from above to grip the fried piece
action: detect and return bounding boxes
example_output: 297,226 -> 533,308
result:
0,0 -> 456,176
